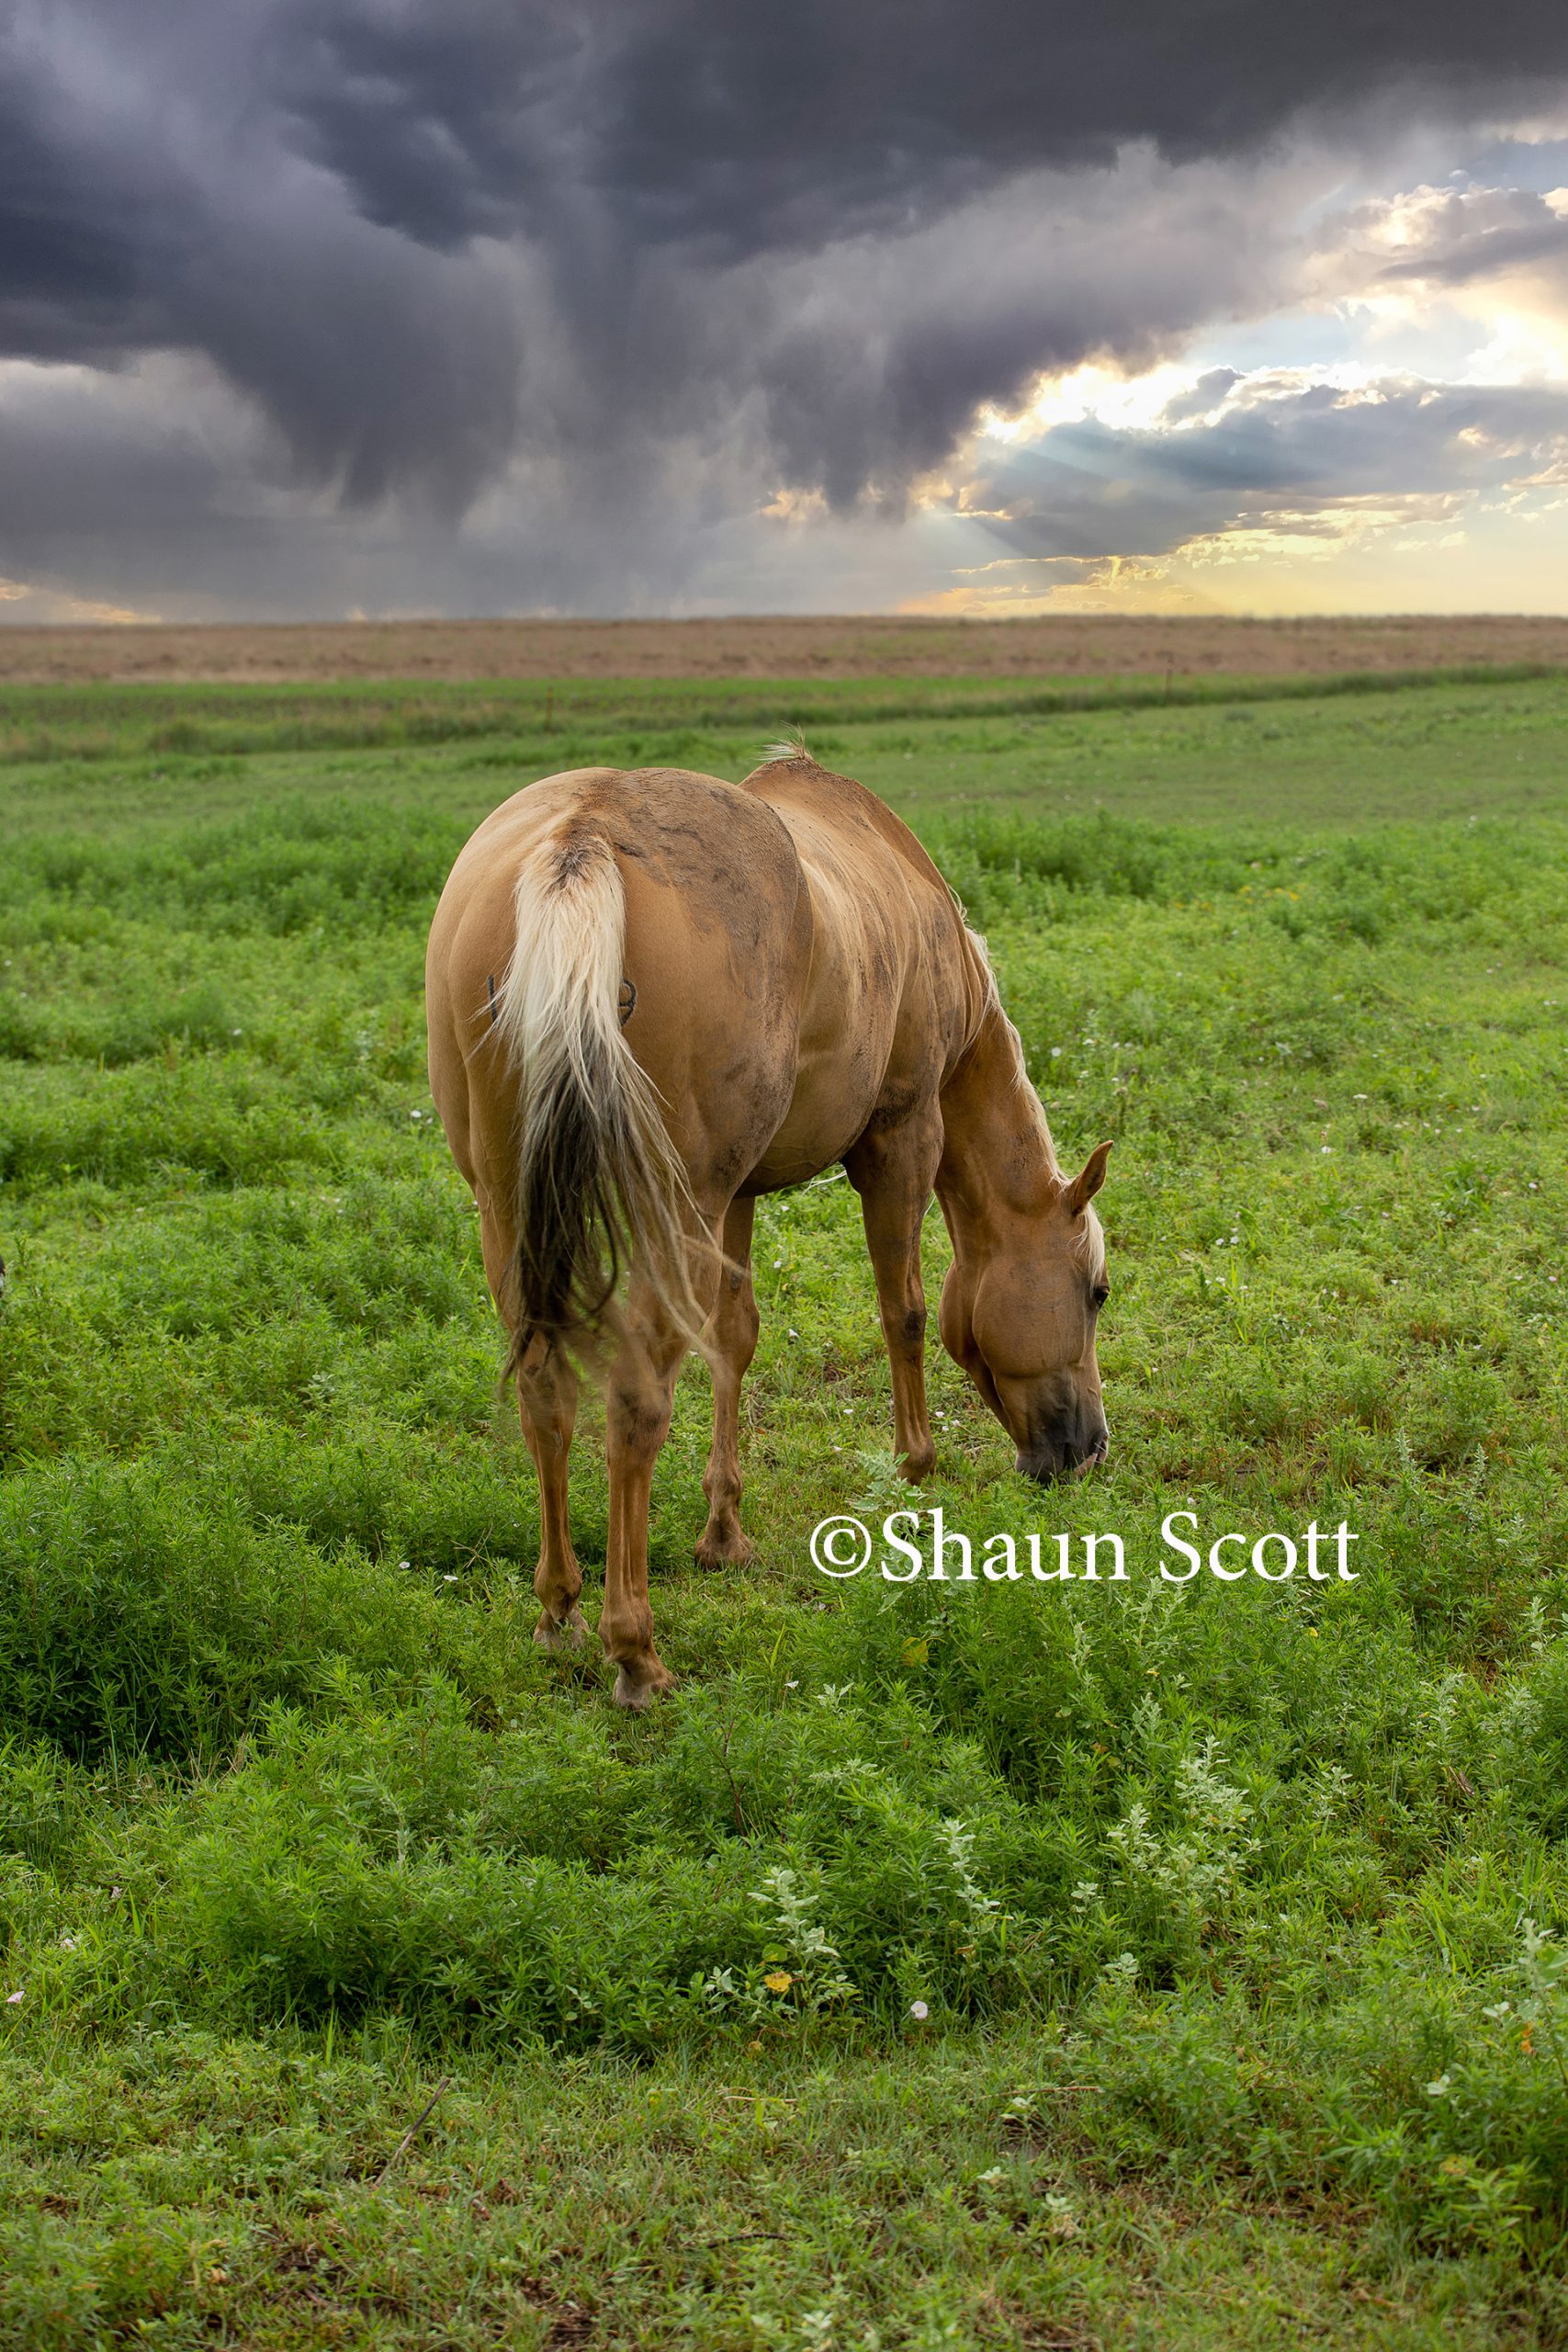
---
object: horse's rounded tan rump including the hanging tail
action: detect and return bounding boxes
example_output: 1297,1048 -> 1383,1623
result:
428,769 -> 811,1366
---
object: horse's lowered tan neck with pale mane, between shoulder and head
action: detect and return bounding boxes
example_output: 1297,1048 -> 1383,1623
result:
936,995 -> 1060,1242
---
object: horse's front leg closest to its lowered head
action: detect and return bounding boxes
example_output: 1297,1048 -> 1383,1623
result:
844,1105 -> 942,1479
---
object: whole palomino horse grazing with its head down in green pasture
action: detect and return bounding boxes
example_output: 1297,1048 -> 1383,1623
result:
425,748 -> 1110,1710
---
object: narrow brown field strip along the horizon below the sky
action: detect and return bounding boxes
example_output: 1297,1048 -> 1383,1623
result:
0,614 -> 1568,684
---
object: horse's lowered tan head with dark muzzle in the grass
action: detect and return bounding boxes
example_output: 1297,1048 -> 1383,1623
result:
941,1143 -> 1110,1479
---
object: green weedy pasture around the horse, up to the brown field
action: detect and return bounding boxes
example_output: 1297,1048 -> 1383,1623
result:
0,677 -> 1568,2352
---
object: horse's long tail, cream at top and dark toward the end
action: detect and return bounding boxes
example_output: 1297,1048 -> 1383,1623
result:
493,826 -> 703,1371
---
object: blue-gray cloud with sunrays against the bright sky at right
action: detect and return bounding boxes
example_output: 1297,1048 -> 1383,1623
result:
949,377 -> 1568,560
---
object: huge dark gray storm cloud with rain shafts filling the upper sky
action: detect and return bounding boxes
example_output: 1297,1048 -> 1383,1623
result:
0,0 -> 1568,536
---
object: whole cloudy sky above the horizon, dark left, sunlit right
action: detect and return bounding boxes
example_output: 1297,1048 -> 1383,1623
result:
0,0 -> 1568,621
